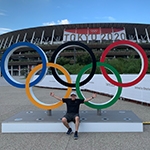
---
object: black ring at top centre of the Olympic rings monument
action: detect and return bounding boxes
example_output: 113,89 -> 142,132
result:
51,41 -> 96,87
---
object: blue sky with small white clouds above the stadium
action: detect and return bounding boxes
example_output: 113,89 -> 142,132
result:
0,0 -> 150,34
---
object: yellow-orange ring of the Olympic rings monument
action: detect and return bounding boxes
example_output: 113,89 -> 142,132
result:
25,63 -> 72,110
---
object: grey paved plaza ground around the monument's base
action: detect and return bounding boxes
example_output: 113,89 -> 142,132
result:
0,77 -> 150,150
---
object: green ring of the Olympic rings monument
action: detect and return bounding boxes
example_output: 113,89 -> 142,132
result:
76,62 -> 122,109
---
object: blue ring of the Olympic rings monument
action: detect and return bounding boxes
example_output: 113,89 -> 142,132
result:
1,42 -> 48,88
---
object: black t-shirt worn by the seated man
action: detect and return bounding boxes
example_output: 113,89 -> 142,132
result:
62,98 -> 84,114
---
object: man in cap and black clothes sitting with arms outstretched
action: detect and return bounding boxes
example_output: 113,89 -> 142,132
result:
50,92 -> 97,140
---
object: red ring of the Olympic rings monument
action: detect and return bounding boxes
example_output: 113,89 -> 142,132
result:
100,40 -> 148,87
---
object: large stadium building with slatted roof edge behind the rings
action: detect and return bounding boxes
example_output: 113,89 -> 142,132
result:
0,23 -> 150,76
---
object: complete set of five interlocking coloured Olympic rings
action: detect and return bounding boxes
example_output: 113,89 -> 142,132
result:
1,40 -> 148,110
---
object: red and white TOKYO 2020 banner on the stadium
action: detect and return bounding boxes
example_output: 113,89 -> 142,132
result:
63,28 -> 126,42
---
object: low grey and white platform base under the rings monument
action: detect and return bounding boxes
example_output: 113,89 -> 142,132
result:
2,110 -> 143,133
